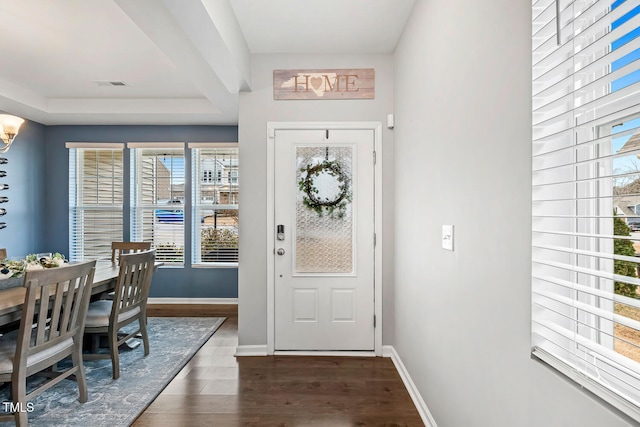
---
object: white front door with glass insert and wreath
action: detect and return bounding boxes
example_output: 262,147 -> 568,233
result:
274,129 -> 375,351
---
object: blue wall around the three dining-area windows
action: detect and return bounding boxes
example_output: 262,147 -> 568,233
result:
44,126 -> 238,298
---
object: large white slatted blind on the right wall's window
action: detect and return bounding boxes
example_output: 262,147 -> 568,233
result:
532,0 -> 640,421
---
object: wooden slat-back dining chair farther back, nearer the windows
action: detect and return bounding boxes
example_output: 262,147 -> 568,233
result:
84,249 -> 156,379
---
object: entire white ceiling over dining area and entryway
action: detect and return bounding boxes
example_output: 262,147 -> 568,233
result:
0,0 -> 415,125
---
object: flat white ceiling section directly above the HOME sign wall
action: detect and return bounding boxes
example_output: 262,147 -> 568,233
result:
230,0 -> 415,54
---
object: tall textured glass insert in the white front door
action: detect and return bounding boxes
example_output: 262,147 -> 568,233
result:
294,145 -> 354,274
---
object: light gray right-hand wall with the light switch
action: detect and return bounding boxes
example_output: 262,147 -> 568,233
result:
393,0 -> 631,427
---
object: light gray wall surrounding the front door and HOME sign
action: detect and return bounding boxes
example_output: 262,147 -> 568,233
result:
238,55 -> 393,345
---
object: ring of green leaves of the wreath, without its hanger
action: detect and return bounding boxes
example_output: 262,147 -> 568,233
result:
298,160 -> 351,218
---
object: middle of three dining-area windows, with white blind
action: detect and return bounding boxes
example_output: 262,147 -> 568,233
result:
127,143 -> 185,265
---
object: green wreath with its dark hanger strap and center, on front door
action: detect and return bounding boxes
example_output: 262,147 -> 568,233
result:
298,147 -> 352,218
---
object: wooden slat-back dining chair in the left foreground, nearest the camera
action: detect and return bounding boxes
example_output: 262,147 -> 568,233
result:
0,261 -> 96,426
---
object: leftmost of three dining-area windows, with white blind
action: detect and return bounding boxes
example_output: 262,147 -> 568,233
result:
67,143 -> 123,261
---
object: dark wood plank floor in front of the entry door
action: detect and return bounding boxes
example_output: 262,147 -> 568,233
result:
133,307 -> 424,427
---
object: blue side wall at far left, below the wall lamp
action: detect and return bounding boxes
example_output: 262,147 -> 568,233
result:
0,121 -> 46,257
